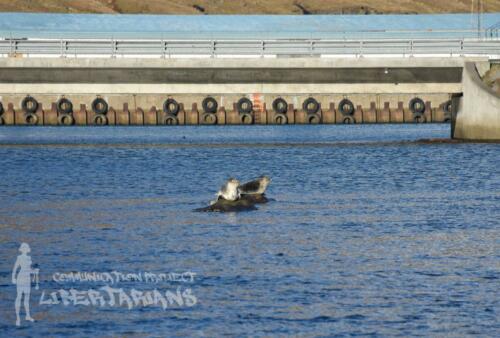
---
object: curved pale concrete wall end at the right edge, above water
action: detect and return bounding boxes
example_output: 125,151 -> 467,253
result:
452,62 -> 500,141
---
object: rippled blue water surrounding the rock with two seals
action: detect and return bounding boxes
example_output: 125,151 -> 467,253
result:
0,125 -> 500,337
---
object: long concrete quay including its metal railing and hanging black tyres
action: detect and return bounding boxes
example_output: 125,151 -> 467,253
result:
0,12 -> 500,139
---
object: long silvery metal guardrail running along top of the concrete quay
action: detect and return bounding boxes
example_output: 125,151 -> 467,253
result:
0,38 -> 500,57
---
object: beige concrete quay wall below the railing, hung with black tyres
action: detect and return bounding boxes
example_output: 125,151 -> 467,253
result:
0,58 -> 483,125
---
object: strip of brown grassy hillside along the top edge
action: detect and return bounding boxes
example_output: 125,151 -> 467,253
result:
0,0 -> 500,14
